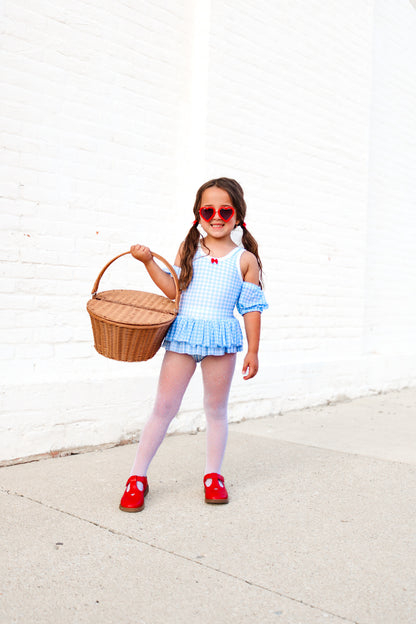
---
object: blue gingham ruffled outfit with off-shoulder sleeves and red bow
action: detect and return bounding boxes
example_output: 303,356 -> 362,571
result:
163,247 -> 268,360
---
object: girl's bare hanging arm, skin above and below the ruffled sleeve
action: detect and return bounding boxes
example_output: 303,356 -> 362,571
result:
241,251 -> 261,379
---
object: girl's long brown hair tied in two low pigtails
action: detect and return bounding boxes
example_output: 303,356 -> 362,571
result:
179,178 -> 263,290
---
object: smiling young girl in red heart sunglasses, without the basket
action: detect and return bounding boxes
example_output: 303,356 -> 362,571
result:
120,178 -> 268,511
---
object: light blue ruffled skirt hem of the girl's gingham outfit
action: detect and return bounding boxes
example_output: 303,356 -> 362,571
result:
163,314 -> 243,355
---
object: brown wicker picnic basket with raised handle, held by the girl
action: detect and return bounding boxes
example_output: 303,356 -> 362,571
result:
87,251 -> 180,362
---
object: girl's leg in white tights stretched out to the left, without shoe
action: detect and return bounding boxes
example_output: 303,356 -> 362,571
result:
130,351 -> 196,477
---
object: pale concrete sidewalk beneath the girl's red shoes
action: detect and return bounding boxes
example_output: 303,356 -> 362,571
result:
0,388 -> 416,624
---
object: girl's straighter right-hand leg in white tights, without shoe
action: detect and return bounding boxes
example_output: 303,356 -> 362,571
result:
201,353 -> 237,474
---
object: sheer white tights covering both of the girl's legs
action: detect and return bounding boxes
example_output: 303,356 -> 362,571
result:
130,351 -> 236,477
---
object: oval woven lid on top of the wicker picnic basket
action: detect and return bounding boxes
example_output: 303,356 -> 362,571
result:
87,290 -> 176,327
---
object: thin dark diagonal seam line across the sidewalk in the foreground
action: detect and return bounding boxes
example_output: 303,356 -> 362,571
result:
0,486 -> 360,624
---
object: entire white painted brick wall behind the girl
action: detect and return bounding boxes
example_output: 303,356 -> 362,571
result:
0,0 -> 416,460
